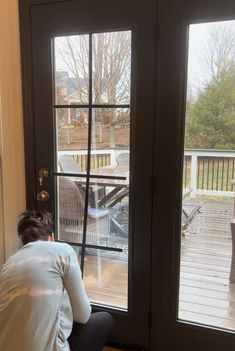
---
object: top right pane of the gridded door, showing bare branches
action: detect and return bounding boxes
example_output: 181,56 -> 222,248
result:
92,31 -> 131,104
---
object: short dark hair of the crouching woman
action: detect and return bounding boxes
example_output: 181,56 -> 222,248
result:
17,210 -> 53,245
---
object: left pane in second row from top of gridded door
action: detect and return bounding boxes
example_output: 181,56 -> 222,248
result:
56,108 -> 88,173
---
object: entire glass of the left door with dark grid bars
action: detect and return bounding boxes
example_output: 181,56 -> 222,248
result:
54,31 -> 131,310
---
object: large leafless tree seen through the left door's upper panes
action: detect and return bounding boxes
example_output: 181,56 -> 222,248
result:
56,31 -> 131,146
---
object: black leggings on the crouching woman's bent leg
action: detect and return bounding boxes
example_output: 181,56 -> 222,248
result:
68,312 -> 114,351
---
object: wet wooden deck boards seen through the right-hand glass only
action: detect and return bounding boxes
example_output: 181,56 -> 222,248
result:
179,200 -> 235,329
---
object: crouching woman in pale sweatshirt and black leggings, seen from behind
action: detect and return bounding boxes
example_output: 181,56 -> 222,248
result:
0,210 -> 114,351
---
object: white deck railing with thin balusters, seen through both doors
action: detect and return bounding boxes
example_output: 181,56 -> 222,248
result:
58,148 -> 235,196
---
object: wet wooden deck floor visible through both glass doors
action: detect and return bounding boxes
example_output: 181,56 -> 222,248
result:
84,199 -> 235,329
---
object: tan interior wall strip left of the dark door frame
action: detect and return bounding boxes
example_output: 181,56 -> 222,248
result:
0,0 -> 25,265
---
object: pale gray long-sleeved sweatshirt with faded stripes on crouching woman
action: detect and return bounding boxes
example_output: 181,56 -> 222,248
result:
0,241 -> 91,351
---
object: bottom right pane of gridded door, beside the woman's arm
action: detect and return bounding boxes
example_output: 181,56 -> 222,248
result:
84,249 -> 128,309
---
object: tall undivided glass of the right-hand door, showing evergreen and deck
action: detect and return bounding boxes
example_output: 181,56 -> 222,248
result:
178,21 -> 235,330
